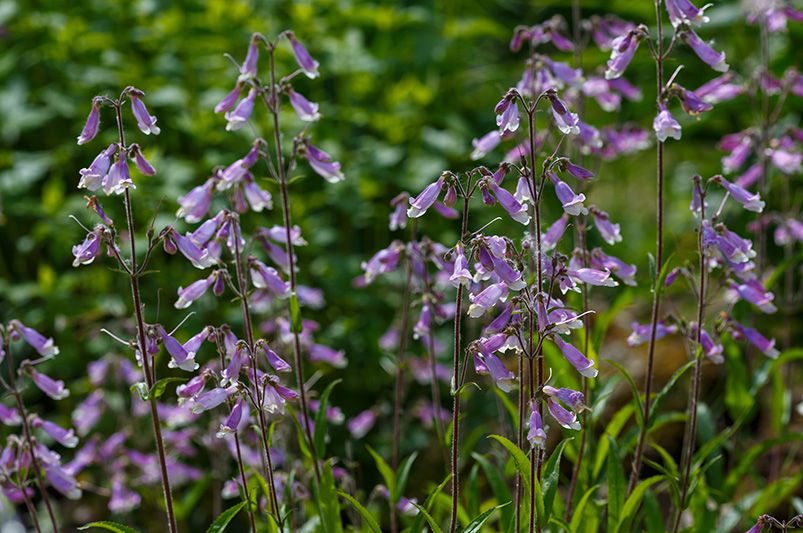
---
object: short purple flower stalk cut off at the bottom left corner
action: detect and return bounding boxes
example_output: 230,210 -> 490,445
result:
0,320 -> 81,533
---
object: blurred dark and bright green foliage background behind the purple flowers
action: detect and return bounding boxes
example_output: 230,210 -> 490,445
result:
0,0 -> 803,528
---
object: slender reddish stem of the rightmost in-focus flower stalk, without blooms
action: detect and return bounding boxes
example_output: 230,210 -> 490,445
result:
672,177 -> 705,533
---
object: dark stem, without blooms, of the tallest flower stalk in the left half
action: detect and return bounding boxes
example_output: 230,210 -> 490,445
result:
268,46 -> 321,484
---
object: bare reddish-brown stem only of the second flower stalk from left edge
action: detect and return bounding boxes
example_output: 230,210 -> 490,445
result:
114,103 -> 178,533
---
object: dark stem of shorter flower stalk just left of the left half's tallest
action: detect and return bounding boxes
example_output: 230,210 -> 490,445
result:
234,221 -> 281,521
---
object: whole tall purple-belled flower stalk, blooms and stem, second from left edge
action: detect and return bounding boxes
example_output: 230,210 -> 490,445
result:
73,86 -> 177,533
